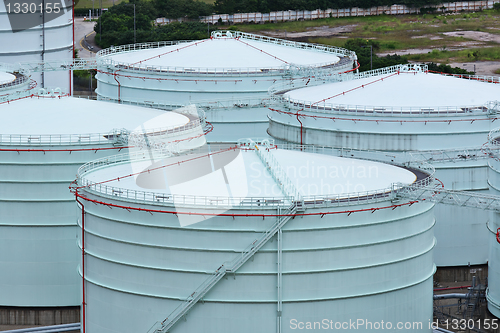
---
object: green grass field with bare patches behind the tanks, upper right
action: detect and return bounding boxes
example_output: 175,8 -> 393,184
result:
238,10 -> 500,63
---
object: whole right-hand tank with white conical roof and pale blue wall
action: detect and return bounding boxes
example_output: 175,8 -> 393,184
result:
268,65 -> 500,266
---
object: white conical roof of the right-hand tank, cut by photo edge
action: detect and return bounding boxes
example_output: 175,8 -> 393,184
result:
285,72 -> 500,107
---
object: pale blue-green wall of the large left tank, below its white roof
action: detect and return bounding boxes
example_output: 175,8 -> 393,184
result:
0,146 -> 122,306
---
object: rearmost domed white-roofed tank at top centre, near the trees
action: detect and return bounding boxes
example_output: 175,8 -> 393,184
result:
96,31 -> 356,142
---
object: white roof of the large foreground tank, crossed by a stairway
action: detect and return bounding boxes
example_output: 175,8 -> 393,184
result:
83,149 -> 416,198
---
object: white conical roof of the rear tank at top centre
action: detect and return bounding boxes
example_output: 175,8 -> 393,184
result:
105,37 -> 340,69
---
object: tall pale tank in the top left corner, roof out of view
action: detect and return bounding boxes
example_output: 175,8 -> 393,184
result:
0,1 -> 73,92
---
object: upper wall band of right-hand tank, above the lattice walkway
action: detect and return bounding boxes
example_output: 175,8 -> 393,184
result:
268,112 -> 491,151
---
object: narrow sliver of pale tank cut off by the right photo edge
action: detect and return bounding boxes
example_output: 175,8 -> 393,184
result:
486,129 -> 500,318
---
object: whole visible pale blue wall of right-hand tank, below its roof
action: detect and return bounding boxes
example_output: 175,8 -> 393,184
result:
268,74 -> 497,266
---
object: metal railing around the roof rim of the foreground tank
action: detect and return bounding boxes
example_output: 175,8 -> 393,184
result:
77,146 -> 434,209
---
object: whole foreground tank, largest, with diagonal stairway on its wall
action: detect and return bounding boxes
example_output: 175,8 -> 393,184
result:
76,145 -> 435,333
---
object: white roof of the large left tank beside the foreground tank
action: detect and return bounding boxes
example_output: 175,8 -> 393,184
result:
0,97 -> 189,136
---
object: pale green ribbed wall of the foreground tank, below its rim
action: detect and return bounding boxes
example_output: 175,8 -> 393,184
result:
79,188 -> 435,332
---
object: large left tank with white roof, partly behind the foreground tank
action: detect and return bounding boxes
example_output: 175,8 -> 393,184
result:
0,93 -> 204,307
